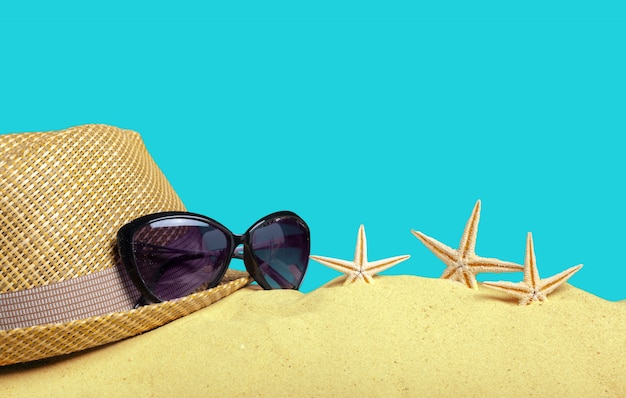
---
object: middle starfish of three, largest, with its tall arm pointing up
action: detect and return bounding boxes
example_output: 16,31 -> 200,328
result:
411,200 -> 524,289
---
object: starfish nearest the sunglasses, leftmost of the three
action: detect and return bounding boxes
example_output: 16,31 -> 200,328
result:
310,225 -> 410,286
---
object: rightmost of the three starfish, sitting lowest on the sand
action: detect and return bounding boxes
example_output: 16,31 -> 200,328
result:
483,232 -> 583,305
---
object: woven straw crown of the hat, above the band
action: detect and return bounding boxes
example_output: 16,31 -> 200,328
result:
0,125 -> 185,293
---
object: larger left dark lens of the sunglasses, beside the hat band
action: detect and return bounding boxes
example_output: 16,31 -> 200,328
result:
132,218 -> 231,301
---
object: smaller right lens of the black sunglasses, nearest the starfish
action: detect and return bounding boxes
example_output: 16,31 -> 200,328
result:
250,218 -> 310,289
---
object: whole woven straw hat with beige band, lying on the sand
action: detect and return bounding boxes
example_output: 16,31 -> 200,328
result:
0,125 -> 250,365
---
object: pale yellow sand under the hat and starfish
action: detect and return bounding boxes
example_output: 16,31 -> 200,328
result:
0,276 -> 626,397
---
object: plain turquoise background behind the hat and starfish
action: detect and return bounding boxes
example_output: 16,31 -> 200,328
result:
0,0 -> 626,300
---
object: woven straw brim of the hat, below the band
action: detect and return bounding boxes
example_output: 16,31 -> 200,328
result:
0,270 -> 252,366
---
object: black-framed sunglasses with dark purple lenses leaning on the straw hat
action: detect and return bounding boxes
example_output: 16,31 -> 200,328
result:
117,211 -> 311,305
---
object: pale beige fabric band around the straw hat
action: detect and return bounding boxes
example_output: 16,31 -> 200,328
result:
0,267 -> 141,330
